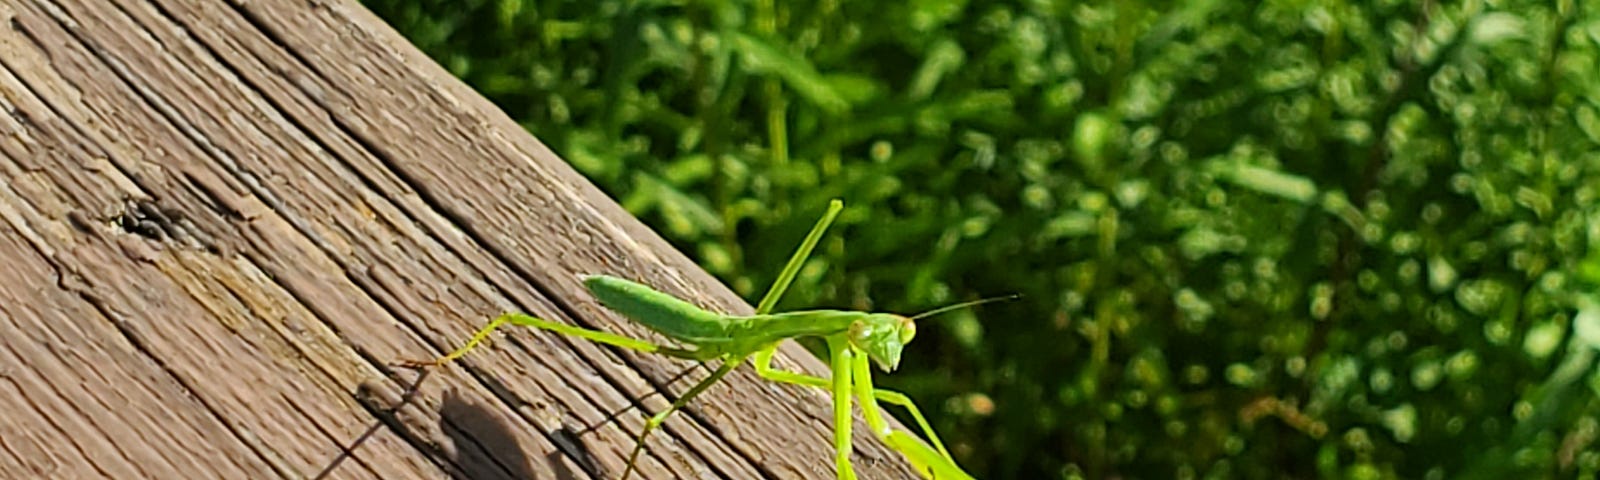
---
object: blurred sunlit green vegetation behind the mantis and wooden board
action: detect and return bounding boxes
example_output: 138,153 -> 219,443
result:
368,0 -> 1600,478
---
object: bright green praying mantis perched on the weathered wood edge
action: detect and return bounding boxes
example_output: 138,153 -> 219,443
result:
402,200 -> 1014,480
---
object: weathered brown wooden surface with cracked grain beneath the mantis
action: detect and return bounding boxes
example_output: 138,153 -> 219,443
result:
0,0 -> 910,478
